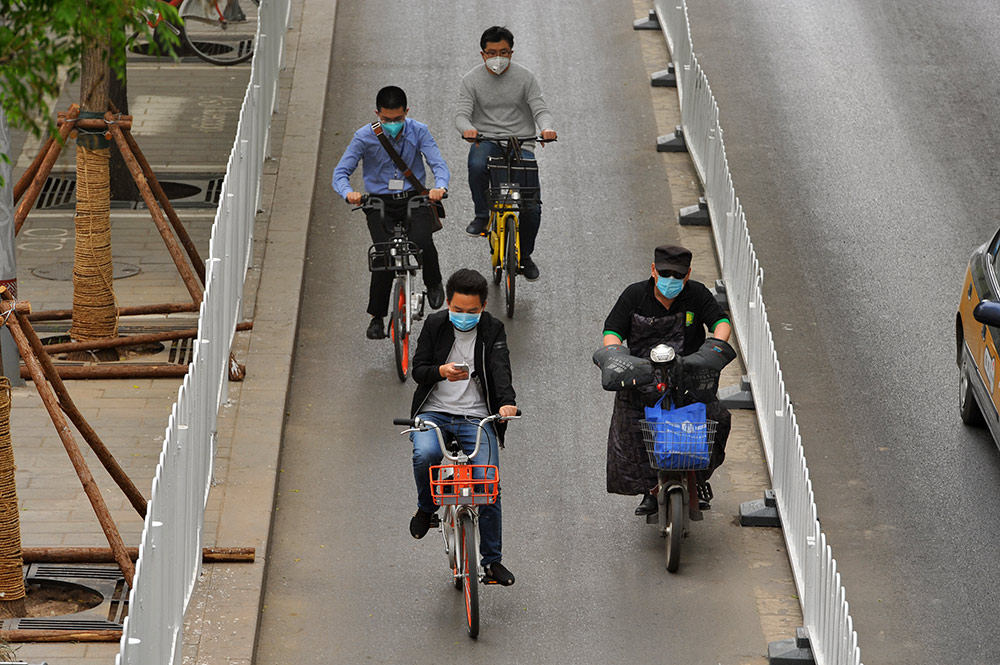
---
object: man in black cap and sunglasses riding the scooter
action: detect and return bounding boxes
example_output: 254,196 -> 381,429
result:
604,245 -> 732,515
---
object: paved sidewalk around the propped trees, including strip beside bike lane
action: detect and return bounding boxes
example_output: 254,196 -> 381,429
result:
5,0 -> 336,664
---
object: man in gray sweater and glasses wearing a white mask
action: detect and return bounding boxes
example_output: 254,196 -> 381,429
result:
455,26 -> 556,280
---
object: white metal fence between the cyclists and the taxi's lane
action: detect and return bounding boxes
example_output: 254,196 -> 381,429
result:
654,0 -> 861,665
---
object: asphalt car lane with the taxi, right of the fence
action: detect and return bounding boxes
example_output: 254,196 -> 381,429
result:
690,0 -> 1000,665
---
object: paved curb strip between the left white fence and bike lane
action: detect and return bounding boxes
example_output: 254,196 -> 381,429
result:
185,0 -> 337,664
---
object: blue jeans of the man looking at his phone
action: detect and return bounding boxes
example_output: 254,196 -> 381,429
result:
410,412 -> 502,566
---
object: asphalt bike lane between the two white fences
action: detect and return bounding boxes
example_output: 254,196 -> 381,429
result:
256,0 -> 795,664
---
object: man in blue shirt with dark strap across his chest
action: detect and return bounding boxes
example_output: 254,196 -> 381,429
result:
333,85 -> 451,339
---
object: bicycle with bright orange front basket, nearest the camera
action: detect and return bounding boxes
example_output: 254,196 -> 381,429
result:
392,409 -> 521,638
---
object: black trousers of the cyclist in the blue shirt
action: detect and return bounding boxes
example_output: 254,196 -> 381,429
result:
365,196 -> 441,318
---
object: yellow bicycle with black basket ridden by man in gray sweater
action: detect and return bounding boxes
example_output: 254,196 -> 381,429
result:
469,134 -> 556,318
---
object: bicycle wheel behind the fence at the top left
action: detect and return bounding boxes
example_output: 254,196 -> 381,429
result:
181,0 -> 260,66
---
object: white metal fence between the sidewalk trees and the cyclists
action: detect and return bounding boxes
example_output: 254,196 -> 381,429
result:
115,0 -> 291,665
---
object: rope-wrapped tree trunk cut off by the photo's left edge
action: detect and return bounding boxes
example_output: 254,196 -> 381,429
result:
0,376 -> 25,617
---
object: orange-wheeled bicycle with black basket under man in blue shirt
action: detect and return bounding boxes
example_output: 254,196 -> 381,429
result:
354,194 -> 442,381
